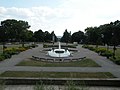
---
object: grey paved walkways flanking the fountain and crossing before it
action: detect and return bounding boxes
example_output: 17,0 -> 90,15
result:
0,44 -> 120,78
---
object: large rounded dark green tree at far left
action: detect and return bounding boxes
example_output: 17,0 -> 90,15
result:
1,19 -> 30,46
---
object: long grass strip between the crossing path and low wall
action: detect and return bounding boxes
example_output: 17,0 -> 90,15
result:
0,71 -> 115,78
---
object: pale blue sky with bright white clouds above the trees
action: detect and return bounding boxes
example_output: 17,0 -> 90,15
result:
0,0 -> 120,36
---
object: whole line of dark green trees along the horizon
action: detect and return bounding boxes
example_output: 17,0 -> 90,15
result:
0,19 -> 120,46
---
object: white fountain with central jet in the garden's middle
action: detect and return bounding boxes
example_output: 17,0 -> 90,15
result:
48,42 -> 70,57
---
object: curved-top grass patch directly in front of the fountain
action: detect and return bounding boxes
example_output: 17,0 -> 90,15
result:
16,59 -> 100,67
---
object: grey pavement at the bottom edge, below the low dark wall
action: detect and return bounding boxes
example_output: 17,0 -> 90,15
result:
5,85 -> 120,90
